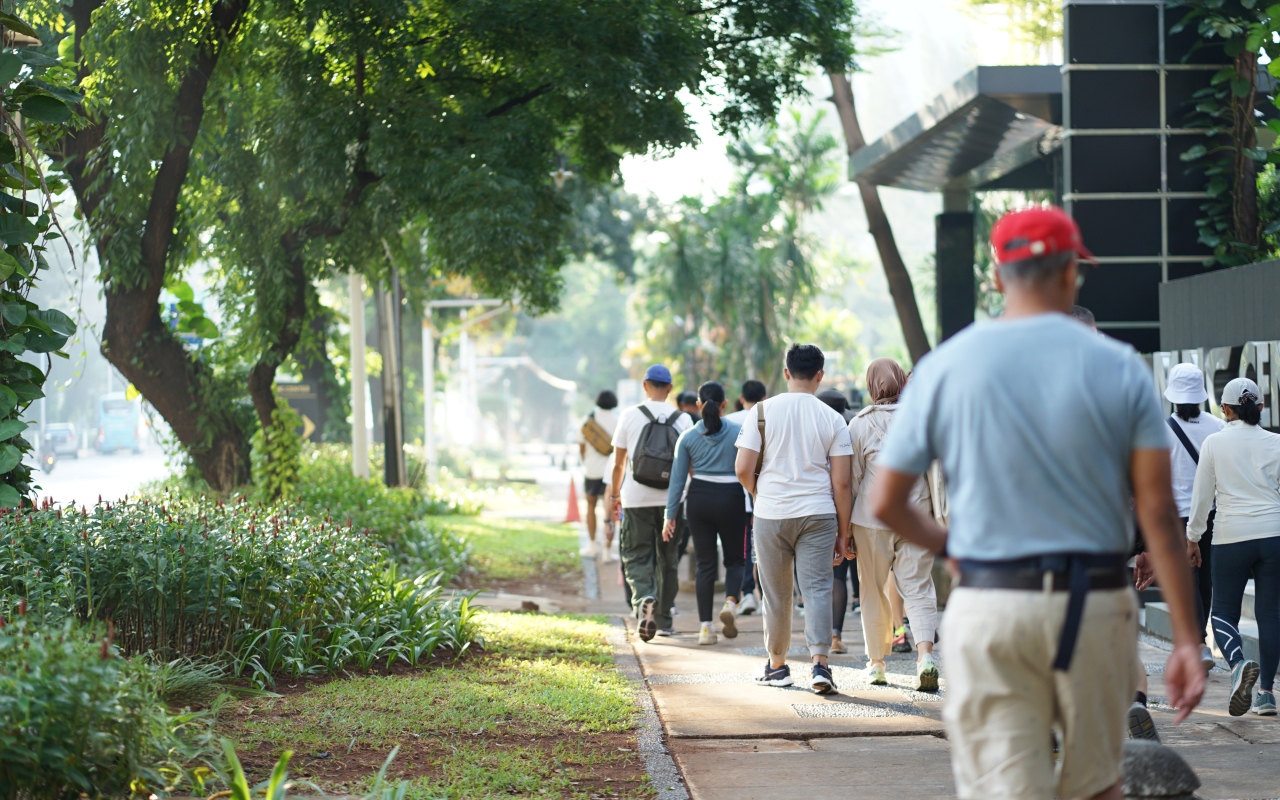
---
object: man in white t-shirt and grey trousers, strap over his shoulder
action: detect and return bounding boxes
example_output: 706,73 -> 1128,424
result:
735,344 -> 854,694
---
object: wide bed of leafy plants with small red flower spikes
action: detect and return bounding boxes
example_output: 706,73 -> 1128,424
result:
0,498 -> 475,685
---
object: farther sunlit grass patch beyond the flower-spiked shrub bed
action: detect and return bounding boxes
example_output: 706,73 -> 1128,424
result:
439,516 -> 582,589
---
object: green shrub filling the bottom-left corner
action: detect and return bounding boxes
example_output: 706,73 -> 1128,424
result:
0,614 -> 216,800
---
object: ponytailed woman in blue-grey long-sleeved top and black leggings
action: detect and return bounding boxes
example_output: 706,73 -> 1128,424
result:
662,380 -> 746,645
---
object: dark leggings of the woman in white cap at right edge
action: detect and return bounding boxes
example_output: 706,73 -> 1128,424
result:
1213,536 -> 1280,691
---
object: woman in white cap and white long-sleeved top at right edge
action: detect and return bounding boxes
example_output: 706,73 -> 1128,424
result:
1187,378 -> 1280,717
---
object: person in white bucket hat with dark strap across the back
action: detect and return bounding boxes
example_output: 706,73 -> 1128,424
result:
1165,364 -> 1226,669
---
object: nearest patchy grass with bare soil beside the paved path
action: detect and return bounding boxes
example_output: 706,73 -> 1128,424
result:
224,609 -> 655,800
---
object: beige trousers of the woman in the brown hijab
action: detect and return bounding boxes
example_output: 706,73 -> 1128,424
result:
854,525 -> 938,662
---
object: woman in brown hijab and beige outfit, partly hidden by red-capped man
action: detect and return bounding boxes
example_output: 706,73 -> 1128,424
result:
849,358 -> 938,691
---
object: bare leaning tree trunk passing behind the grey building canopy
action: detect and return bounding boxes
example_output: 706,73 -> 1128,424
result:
829,73 -> 929,362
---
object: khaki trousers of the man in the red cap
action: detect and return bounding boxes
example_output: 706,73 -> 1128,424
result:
942,583 -> 1140,800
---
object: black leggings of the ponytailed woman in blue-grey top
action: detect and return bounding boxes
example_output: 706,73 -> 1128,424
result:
685,477 -> 746,622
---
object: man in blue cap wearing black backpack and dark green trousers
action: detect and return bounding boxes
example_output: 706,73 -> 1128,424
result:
609,364 -> 692,641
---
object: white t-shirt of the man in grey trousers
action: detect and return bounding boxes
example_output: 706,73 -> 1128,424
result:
737,392 -> 854,520
